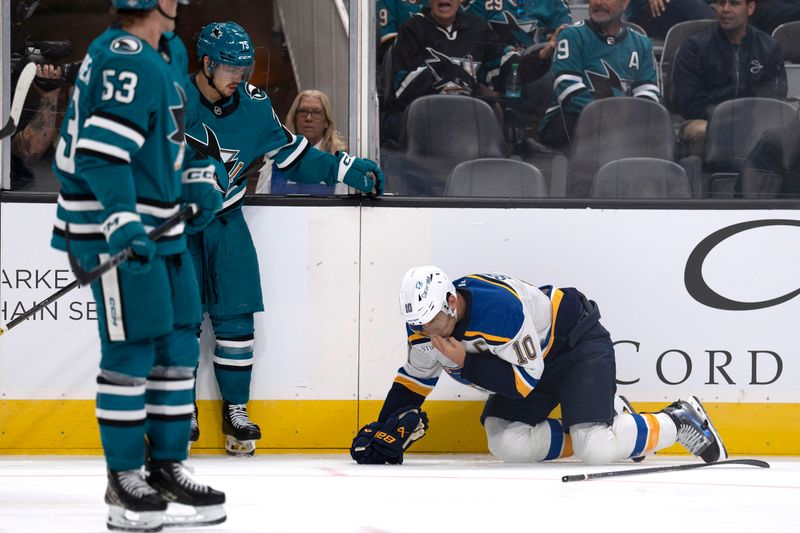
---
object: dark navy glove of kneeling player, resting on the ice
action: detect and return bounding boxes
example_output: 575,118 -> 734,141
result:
350,407 -> 428,465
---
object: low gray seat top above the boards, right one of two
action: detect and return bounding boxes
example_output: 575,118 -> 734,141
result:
591,157 -> 692,198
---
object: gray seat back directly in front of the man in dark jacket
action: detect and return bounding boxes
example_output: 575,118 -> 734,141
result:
703,98 -> 795,198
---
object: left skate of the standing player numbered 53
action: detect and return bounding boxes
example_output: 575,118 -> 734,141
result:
106,469 -> 167,531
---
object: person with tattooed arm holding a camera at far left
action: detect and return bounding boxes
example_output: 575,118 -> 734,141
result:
11,65 -> 61,191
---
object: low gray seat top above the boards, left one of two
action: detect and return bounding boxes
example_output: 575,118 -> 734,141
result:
444,159 -> 548,198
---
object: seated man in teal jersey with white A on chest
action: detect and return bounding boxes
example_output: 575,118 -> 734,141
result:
539,0 -> 661,150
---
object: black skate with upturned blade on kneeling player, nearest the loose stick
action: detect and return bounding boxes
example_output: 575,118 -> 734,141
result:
661,396 -> 728,463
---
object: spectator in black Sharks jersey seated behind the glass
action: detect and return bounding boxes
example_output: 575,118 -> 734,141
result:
381,0 -> 502,141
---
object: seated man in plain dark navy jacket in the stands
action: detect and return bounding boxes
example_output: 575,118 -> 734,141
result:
672,0 -> 787,157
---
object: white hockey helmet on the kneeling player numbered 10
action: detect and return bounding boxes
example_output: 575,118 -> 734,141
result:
400,265 -> 456,329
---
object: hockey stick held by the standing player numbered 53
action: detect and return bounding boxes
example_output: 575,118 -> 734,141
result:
0,204 -> 198,335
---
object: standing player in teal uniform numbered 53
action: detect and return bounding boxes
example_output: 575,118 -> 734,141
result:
51,0 -> 226,531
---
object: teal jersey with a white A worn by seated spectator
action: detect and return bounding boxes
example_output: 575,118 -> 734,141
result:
539,21 -> 661,131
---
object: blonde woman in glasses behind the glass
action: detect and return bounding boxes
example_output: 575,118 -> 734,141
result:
256,89 -> 348,196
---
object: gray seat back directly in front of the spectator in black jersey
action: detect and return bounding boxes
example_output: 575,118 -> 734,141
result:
401,95 -> 506,196
